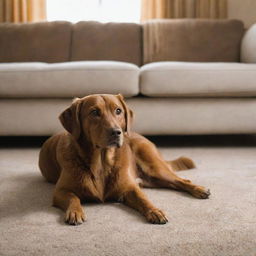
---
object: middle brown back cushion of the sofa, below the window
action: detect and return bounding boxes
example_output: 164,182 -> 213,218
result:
71,21 -> 142,65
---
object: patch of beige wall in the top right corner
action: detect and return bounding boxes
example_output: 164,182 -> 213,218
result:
228,0 -> 256,28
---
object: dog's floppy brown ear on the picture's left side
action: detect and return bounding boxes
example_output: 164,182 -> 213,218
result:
59,98 -> 82,140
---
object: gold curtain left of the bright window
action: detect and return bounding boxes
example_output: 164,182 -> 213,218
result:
0,0 -> 46,23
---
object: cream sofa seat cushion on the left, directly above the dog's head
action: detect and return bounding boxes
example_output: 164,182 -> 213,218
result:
0,61 -> 139,98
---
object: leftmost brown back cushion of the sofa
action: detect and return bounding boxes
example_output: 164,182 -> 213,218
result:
0,21 -> 72,62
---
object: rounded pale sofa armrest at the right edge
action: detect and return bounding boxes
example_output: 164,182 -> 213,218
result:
241,24 -> 256,63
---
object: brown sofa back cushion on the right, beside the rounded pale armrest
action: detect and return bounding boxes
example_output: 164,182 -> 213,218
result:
143,19 -> 244,63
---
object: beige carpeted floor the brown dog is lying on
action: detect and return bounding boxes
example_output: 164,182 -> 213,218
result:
0,136 -> 256,256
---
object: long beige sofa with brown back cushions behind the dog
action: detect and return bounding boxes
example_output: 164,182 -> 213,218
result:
0,19 -> 256,136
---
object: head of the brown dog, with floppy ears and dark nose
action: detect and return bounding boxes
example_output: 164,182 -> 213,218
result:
59,94 -> 133,148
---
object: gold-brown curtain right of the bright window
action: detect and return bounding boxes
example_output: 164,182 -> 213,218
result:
141,0 -> 227,21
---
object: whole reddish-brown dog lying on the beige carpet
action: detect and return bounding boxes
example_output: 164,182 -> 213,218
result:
39,94 -> 210,225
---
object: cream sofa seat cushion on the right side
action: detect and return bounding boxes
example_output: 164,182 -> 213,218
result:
140,62 -> 256,97
